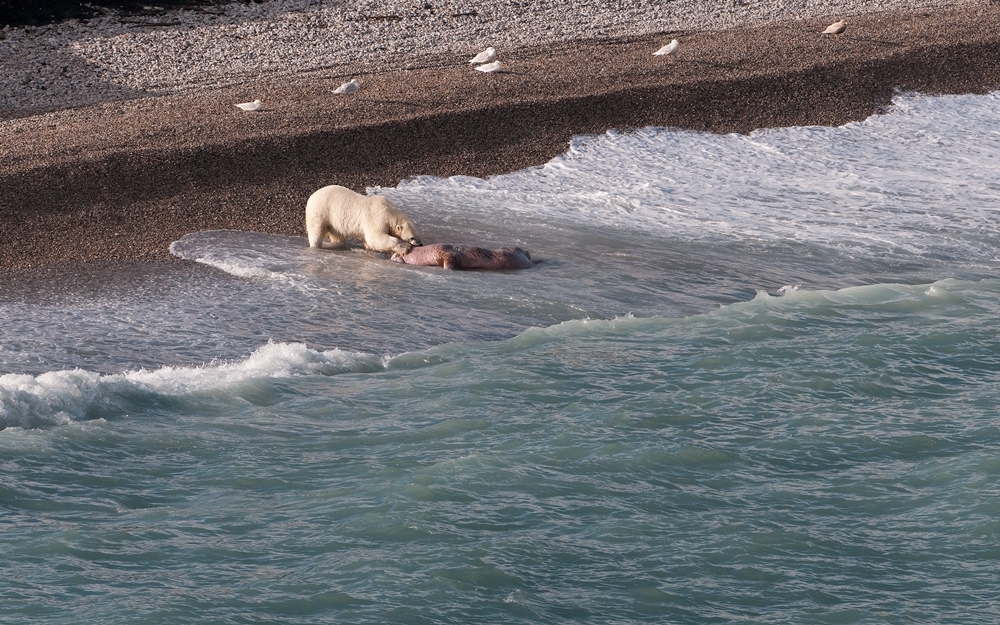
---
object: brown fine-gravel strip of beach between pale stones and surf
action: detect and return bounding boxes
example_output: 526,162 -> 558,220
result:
0,4 -> 1000,276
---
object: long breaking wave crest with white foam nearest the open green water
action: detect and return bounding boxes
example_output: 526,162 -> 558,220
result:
9,279 -> 1000,429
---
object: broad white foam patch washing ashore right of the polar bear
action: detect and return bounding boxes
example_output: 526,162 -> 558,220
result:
380,93 -> 1000,262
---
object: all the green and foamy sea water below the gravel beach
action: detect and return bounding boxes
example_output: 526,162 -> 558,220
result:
0,94 -> 1000,624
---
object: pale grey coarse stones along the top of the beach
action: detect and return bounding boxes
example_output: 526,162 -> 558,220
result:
0,0 -> 990,120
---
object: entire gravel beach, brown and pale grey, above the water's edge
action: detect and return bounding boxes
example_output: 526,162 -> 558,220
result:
0,0 -> 1000,272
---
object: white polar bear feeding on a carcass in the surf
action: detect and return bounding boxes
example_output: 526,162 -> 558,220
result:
306,184 -> 420,254
